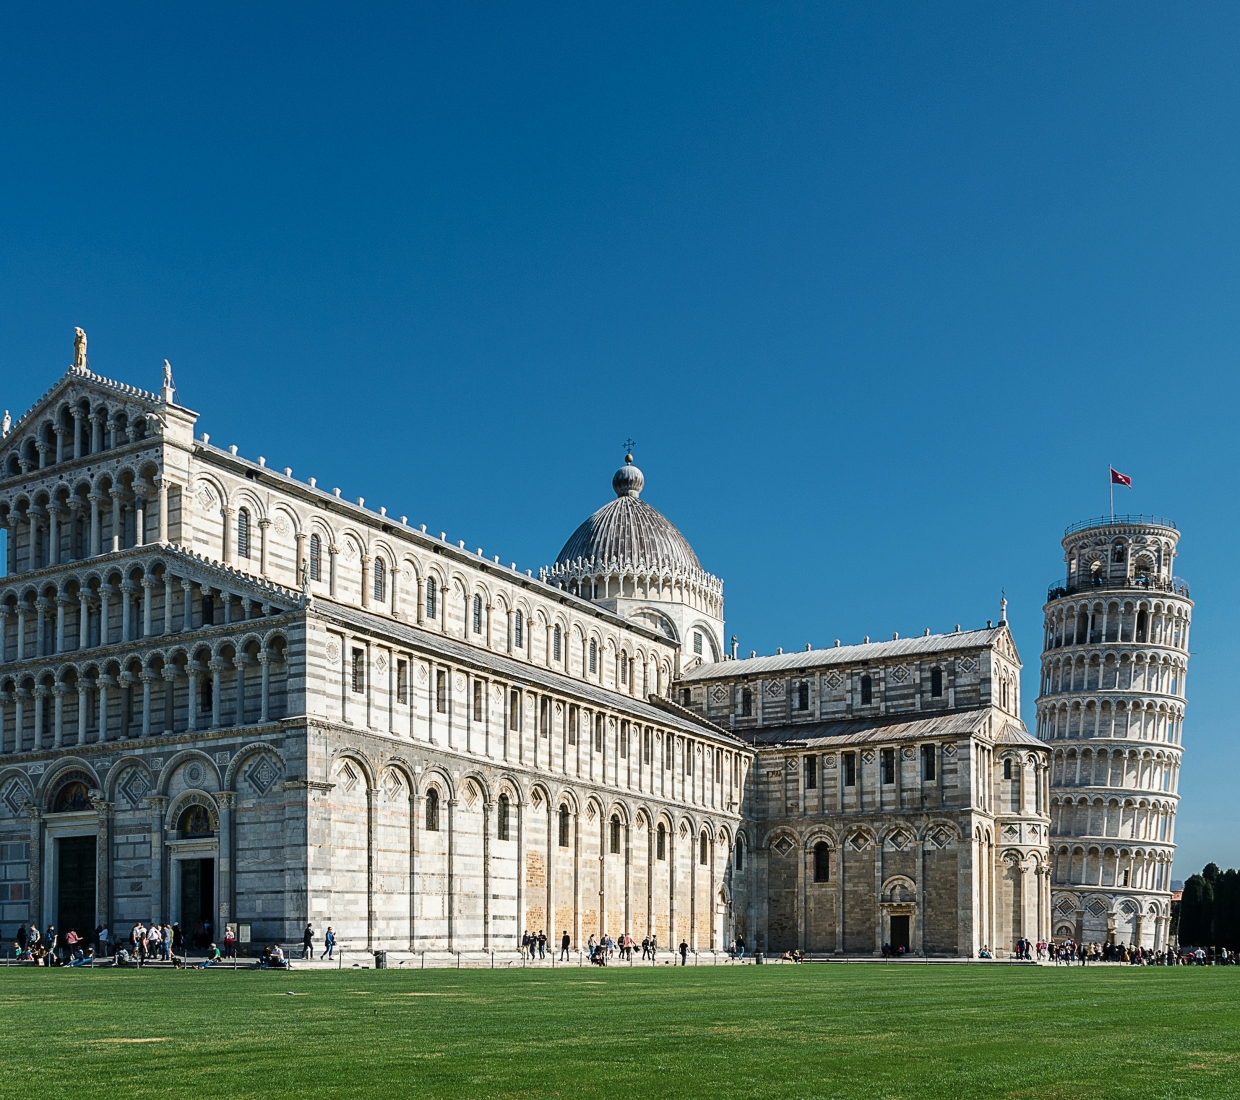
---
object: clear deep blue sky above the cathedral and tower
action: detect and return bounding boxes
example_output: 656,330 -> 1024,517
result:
0,2 -> 1240,877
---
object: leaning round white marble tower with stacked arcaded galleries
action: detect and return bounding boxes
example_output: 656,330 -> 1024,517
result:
1038,516 -> 1193,947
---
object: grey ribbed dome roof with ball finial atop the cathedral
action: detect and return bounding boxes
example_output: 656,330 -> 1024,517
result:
556,455 -> 703,575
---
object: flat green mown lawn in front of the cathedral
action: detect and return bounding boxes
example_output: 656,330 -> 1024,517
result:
0,964 -> 1240,1100
